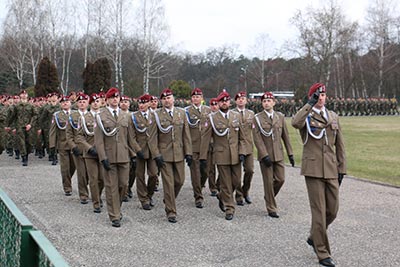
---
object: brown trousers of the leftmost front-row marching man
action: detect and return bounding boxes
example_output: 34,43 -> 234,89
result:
104,162 -> 129,221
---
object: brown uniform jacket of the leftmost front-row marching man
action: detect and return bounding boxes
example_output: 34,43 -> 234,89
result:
94,108 -> 140,164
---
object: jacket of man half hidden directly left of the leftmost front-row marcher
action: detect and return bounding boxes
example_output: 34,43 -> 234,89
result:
76,112 -> 97,159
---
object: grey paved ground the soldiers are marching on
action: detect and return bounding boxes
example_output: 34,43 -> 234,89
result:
0,153 -> 400,267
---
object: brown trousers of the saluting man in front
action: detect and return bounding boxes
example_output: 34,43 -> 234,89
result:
306,176 -> 339,260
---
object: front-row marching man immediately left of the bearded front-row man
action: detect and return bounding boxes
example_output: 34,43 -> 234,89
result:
149,88 -> 192,223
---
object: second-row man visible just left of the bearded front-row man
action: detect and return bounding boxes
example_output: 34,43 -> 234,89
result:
185,88 -> 211,209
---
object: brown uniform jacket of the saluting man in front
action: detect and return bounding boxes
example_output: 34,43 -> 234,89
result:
292,104 -> 346,178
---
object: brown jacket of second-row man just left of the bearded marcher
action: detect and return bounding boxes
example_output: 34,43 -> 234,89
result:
185,105 -> 211,153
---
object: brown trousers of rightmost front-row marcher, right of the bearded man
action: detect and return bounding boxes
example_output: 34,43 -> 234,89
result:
260,160 -> 285,213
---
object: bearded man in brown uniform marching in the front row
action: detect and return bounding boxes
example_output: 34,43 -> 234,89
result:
200,91 -> 246,220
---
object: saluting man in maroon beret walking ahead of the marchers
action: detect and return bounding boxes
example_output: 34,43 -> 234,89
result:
292,83 -> 346,266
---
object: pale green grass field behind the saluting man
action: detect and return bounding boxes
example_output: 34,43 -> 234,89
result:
287,116 -> 400,186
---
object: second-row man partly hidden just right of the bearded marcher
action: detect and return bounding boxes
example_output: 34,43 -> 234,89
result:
233,92 -> 254,206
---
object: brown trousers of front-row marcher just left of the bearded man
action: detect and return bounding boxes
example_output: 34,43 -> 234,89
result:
161,161 -> 185,217
